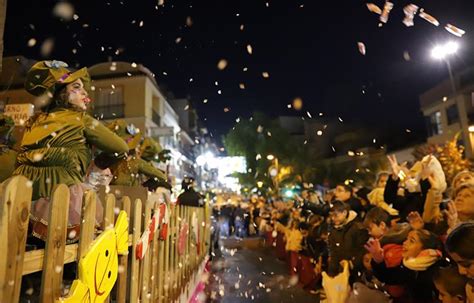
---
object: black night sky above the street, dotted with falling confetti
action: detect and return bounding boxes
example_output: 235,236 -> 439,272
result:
4,0 -> 474,150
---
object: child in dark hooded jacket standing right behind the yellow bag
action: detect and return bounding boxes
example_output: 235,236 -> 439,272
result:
328,201 -> 369,277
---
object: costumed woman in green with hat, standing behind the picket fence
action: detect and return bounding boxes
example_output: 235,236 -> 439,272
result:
14,61 -> 128,240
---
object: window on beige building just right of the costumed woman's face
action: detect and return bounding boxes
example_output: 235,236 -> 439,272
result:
94,87 -> 124,119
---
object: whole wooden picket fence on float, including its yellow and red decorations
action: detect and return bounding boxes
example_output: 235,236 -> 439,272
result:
0,176 -> 210,303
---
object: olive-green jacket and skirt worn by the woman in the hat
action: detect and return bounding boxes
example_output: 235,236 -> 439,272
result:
14,108 -> 128,200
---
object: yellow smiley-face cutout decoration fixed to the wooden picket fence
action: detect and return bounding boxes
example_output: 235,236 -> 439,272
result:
56,211 -> 128,303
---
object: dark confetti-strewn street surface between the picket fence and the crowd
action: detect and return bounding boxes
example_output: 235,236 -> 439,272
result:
207,238 -> 319,303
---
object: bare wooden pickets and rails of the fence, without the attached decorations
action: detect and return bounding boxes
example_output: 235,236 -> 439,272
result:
0,176 -> 210,303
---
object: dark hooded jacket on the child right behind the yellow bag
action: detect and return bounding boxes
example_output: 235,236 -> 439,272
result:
328,210 -> 369,274
